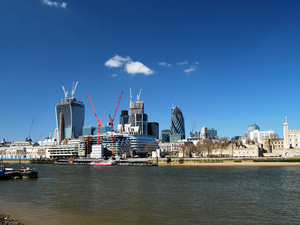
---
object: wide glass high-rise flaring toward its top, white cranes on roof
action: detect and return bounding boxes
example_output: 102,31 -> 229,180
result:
55,83 -> 85,141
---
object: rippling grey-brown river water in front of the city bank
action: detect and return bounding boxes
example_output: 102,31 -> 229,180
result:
0,164 -> 300,225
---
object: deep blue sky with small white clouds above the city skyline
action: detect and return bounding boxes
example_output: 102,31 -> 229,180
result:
0,0 -> 300,141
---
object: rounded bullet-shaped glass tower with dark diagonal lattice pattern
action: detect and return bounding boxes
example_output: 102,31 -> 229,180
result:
170,106 -> 185,141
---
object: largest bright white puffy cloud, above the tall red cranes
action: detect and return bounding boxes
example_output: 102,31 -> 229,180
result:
104,55 -> 154,76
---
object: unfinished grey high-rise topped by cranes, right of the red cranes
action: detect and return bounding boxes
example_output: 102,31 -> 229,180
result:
128,89 -> 148,134
